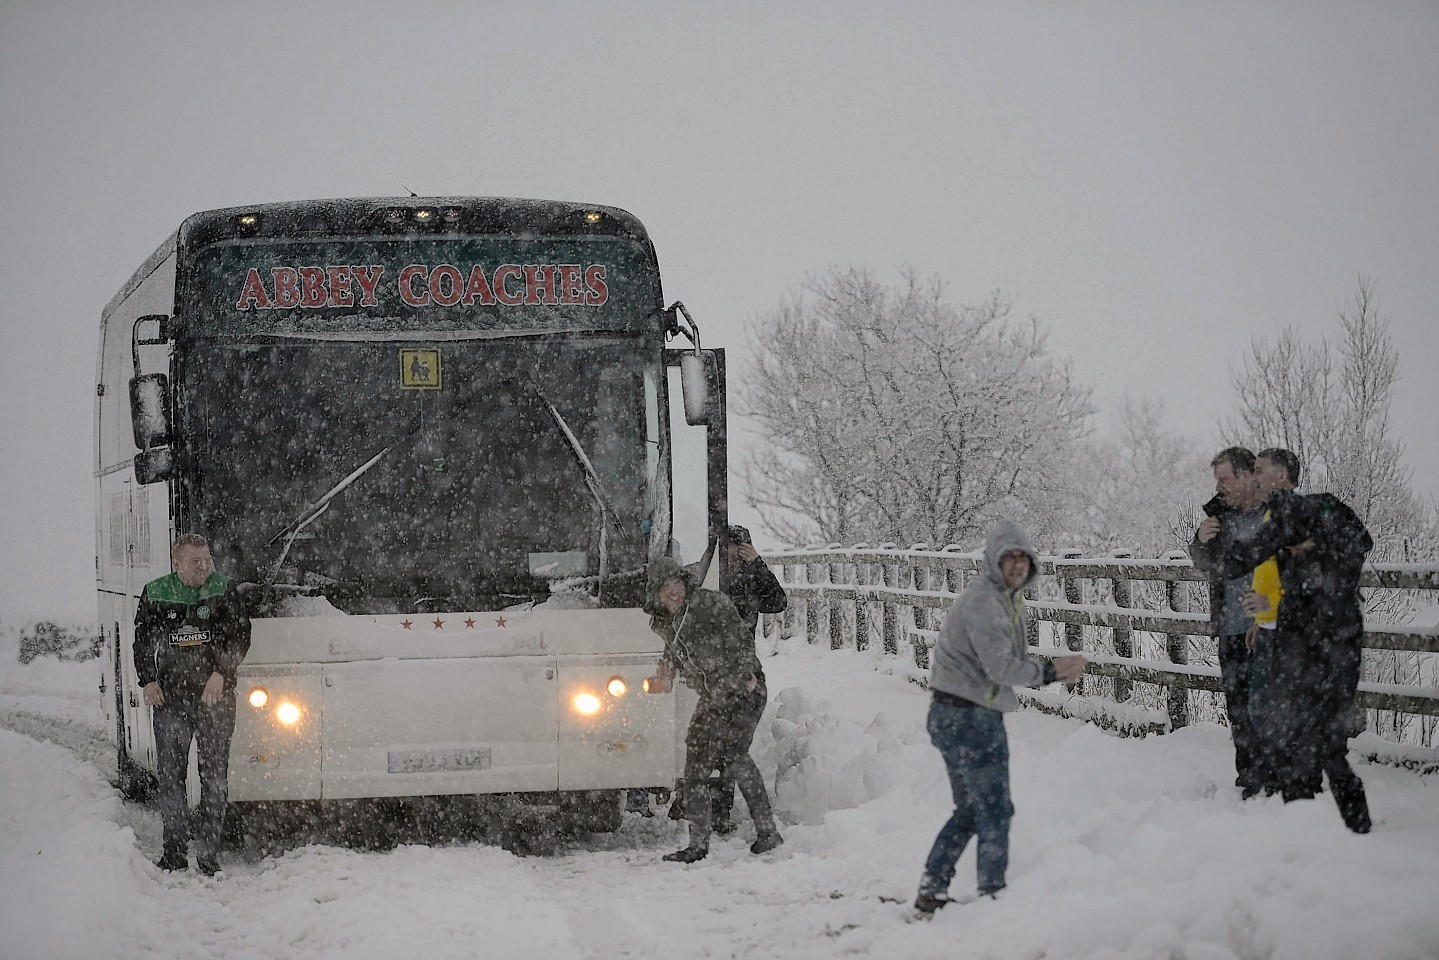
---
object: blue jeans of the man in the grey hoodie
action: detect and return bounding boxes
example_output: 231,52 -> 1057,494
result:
920,699 -> 1014,897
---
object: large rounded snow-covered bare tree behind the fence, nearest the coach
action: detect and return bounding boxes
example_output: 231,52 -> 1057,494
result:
737,268 -> 1092,544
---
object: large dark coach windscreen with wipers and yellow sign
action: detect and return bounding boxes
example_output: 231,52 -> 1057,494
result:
183,334 -> 668,613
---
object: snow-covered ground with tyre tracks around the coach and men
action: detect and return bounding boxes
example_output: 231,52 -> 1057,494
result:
0,630 -> 1439,960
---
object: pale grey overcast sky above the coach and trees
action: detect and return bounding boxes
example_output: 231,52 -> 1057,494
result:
0,0 -> 1439,617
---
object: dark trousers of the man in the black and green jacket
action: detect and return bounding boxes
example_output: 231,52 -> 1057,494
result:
151,691 -> 235,856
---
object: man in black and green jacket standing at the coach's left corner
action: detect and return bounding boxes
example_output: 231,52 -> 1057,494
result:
134,534 -> 250,875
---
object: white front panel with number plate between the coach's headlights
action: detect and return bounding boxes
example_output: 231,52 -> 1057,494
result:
321,656 -> 560,799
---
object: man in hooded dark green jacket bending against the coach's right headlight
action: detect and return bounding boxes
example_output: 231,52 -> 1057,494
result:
645,557 -> 784,864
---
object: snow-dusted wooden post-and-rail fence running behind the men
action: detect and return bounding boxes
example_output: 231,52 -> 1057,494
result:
764,544 -> 1439,730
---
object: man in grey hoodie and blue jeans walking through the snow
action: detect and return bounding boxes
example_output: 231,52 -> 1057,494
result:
914,520 -> 1085,915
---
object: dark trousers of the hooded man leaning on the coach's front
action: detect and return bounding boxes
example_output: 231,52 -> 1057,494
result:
684,682 -> 774,846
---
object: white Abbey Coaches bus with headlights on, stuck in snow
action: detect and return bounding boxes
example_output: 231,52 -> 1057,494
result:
95,197 -> 728,829
